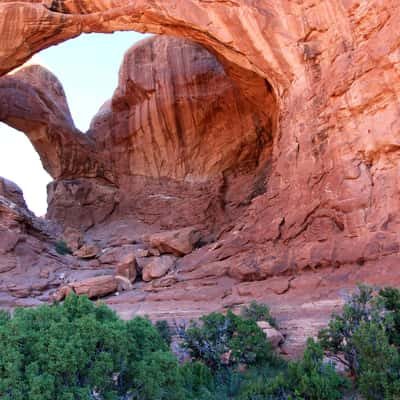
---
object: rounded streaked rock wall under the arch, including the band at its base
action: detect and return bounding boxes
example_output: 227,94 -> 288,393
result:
87,36 -> 277,228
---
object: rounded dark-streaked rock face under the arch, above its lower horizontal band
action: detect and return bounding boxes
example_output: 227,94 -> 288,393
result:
89,36 -> 274,183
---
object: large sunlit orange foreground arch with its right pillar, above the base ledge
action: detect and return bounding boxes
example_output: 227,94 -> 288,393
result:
0,0 -> 400,276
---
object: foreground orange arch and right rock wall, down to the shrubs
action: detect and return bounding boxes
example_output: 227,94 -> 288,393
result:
0,0 -> 400,354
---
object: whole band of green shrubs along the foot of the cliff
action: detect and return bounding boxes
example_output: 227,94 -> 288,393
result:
0,286 -> 400,400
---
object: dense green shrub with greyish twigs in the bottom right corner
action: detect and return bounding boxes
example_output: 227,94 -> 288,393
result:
319,285 -> 400,400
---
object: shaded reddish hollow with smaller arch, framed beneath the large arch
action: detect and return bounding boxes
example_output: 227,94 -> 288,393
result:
0,36 -> 278,241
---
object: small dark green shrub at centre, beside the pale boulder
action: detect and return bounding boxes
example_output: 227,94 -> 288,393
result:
183,311 -> 273,370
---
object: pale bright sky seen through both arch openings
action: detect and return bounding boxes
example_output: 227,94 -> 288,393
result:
0,32 -> 144,216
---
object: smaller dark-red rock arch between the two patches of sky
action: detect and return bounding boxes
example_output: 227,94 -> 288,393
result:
0,65 -> 115,183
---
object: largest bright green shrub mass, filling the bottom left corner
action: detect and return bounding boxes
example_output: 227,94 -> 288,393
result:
0,295 -> 182,400
